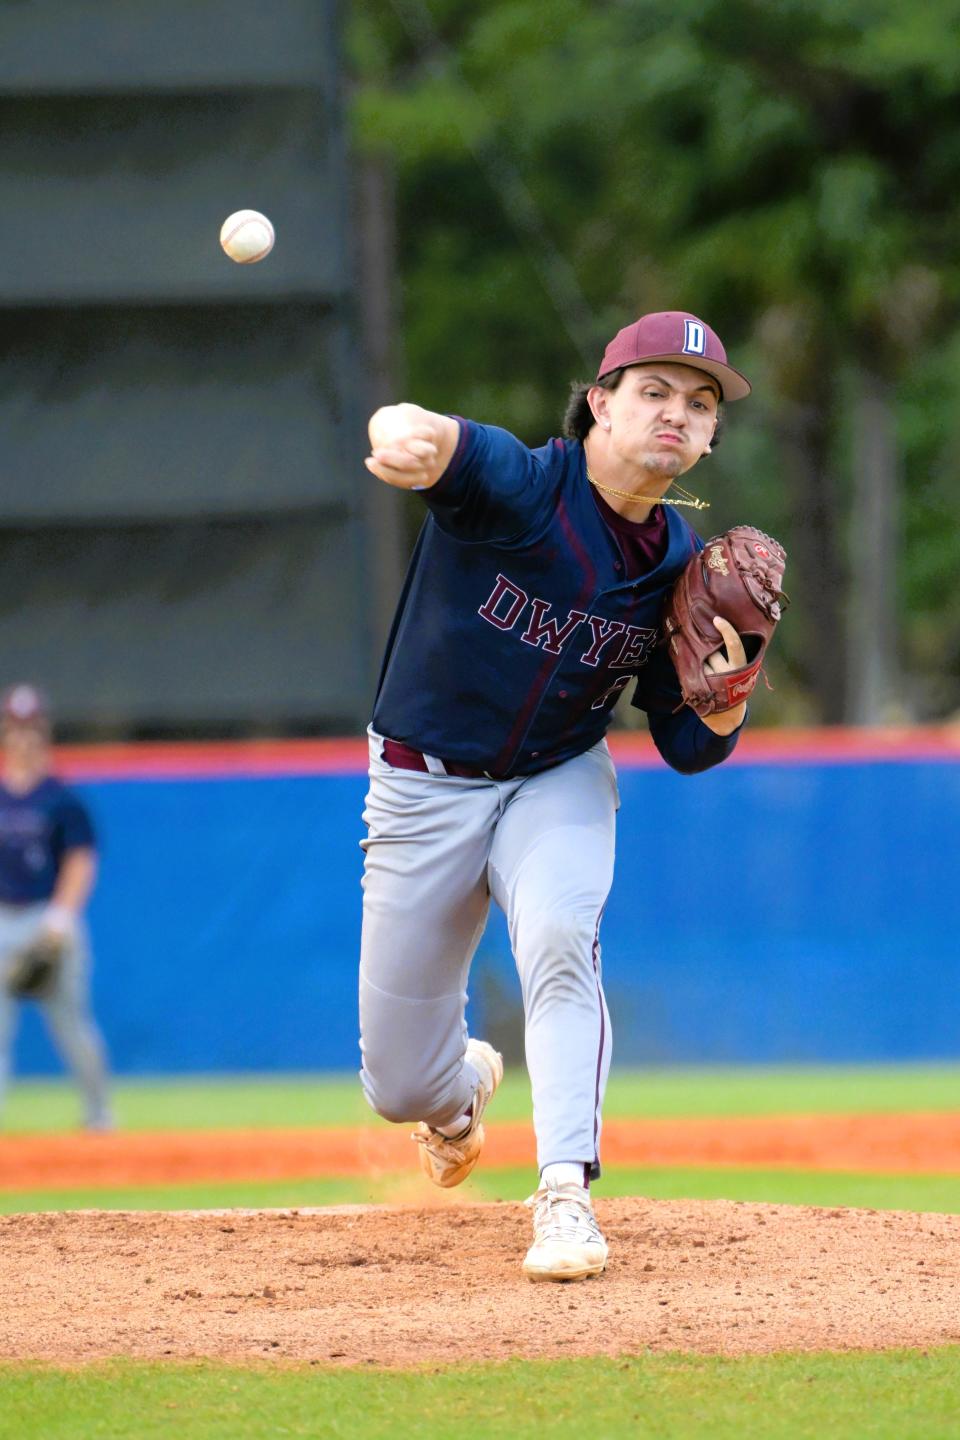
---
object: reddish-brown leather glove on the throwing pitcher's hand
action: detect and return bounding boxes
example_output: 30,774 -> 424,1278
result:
664,526 -> 789,716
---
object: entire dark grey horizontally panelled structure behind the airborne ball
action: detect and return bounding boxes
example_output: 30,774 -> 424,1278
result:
0,0 -> 376,736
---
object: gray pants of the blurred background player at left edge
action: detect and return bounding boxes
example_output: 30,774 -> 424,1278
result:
0,901 -> 111,1129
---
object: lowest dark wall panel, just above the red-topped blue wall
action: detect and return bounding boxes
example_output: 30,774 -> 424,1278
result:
0,516 -> 370,733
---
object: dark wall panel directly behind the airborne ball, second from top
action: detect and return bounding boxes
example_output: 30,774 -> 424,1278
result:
0,91 -> 344,305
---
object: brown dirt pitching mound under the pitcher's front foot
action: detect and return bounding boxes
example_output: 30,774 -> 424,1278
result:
0,1200 -> 960,1365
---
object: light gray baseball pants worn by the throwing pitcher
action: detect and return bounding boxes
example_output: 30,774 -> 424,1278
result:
360,733 -> 619,1175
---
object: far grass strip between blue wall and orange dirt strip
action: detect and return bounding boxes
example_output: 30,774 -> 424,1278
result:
3,1064 -> 960,1132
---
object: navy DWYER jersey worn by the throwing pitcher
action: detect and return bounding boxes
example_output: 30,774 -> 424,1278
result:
373,420 -> 737,778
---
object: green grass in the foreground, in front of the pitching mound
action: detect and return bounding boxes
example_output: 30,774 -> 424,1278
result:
0,1348 -> 960,1440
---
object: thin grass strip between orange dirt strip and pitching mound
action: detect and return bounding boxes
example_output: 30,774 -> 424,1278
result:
0,1155 -> 960,1215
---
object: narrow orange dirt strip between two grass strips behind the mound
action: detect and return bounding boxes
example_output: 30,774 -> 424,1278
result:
0,1113 -> 960,1192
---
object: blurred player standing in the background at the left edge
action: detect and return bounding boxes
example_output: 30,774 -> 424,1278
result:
0,685 -> 112,1130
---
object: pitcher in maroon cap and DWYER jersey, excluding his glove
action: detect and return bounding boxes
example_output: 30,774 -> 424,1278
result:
360,311 -> 750,1280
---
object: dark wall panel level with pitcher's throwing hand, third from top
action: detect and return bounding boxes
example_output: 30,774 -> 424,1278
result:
0,304 -> 356,526
